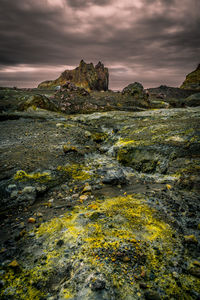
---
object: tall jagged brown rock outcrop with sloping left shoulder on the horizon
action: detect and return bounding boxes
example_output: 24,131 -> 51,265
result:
38,60 -> 109,91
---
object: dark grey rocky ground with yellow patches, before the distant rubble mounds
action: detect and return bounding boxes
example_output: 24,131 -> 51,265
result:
0,92 -> 200,300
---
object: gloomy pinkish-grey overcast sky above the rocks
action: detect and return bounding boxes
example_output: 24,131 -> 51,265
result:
0,0 -> 200,90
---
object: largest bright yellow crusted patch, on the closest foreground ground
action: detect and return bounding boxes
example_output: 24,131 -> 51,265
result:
1,195 -> 198,299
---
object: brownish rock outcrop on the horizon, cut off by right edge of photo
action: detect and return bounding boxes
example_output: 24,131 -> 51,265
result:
180,64 -> 200,91
